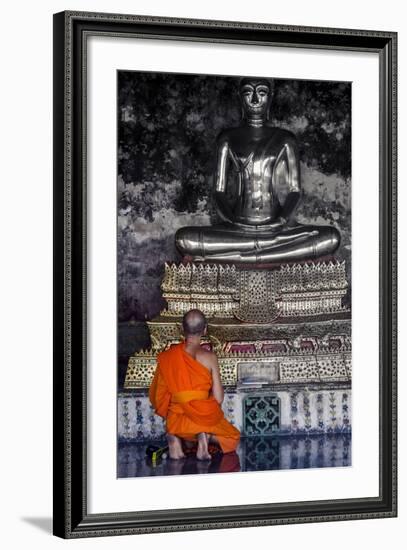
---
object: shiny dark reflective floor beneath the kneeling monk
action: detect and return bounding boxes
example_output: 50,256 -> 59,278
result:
117,433 -> 351,477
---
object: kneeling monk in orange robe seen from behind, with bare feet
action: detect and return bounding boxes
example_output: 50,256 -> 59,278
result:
149,309 -> 240,460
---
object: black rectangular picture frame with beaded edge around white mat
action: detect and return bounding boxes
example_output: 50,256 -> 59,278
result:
53,11 -> 397,538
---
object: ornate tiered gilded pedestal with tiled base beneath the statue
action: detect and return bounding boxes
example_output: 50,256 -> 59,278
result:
119,261 -> 351,440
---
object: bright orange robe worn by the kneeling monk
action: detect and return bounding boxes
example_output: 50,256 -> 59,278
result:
149,342 -> 240,453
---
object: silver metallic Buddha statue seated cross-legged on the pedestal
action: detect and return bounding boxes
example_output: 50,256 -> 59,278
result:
175,78 -> 340,264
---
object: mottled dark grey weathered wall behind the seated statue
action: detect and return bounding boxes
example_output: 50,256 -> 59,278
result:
117,71 -> 351,321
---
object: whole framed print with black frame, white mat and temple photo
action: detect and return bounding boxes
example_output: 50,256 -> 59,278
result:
54,12 -> 397,538
